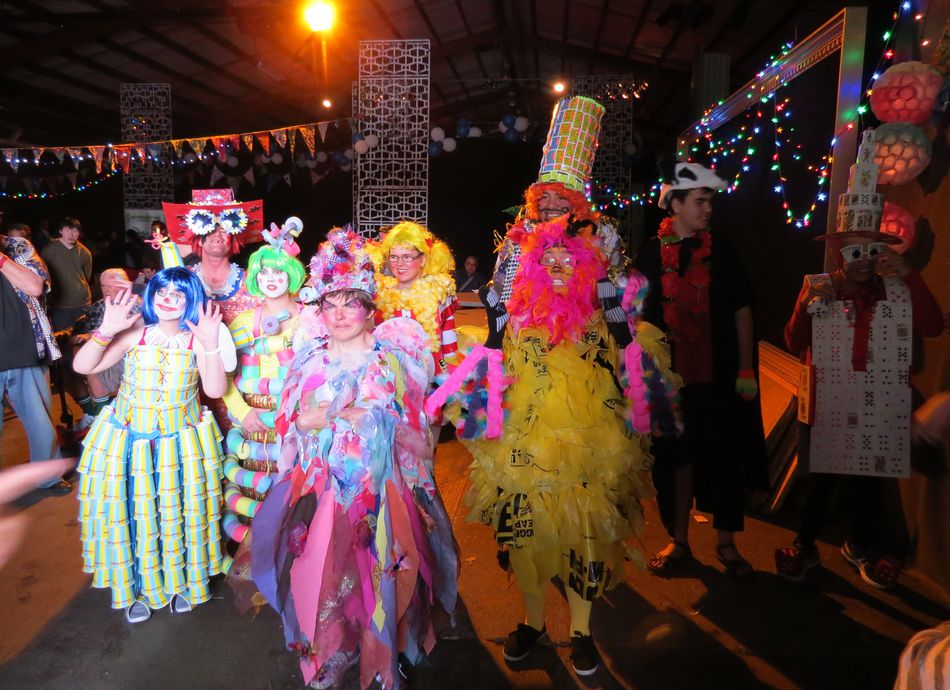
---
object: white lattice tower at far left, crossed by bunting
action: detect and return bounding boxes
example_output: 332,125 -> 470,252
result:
119,84 -> 174,209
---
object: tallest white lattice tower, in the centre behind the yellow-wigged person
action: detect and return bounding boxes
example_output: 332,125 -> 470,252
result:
353,39 -> 430,237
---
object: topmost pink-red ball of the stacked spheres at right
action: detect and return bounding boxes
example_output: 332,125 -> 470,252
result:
871,61 -> 943,125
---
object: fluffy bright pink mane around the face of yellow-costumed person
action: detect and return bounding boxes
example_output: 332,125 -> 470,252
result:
508,218 -> 606,345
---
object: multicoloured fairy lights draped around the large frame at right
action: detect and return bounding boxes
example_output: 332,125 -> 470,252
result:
585,0 -> 924,228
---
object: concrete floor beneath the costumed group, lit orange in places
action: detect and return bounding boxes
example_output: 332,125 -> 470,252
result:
0,396 -> 950,690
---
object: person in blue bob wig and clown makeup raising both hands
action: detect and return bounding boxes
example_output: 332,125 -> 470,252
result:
73,267 -> 235,623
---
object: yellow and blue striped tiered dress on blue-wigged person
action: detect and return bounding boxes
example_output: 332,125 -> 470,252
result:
79,329 -> 223,609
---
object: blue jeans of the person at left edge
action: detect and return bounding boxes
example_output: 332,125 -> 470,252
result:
0,366 -> 60,488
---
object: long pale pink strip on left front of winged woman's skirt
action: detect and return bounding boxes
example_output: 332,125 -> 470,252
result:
290,494 -> 336,683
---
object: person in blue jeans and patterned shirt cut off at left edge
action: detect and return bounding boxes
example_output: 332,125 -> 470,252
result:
0,237 -> 72,494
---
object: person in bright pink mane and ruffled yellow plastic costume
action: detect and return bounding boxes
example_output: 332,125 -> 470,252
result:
442,216 -> 675,676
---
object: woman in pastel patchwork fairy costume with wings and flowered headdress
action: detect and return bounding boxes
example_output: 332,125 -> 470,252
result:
250,229 -> 458,690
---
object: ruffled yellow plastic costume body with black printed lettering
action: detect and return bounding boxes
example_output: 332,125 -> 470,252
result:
463,311 -> 653,600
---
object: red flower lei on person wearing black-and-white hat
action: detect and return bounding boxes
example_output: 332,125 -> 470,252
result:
657,218 -> 712,341
